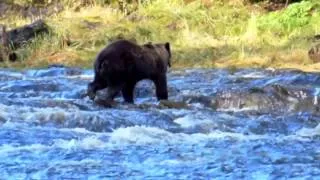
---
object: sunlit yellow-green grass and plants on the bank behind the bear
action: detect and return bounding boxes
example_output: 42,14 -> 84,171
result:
0,0 -> 320,71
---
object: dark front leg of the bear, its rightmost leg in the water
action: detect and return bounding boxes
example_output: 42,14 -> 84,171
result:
153,74 -> 168,100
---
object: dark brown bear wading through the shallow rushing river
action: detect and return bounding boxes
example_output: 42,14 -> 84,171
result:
87,40 -> 171,103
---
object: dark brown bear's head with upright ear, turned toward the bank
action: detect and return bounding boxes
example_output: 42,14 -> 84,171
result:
143,42 -> 171,67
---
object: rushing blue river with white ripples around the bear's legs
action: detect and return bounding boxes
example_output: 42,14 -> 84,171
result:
0,67 -> 320,179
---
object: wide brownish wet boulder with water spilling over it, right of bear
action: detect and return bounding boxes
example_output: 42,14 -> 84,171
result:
215,84 -> 320,114
